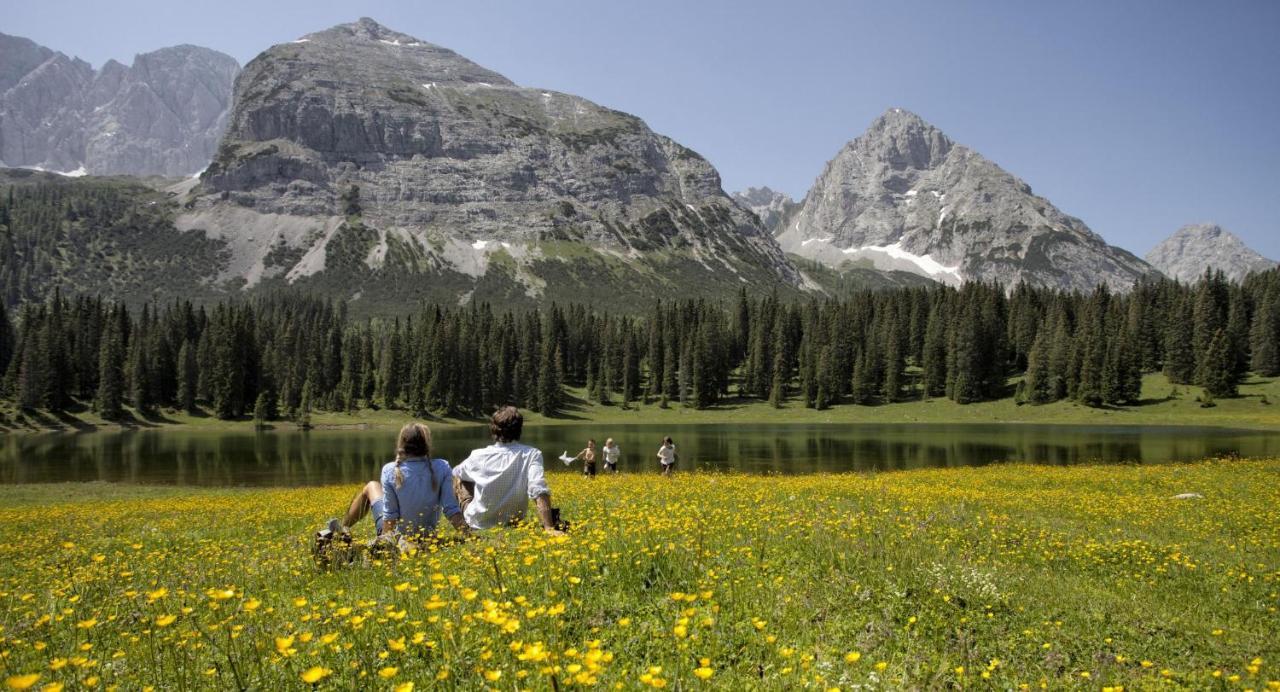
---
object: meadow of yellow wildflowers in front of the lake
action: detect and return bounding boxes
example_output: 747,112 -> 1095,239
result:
0,459 -> 1280,691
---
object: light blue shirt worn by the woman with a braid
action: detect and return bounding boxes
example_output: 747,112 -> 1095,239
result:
381,458 -> 462,535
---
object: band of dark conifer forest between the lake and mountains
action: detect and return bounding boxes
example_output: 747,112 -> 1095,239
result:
0,270 -> 1280,420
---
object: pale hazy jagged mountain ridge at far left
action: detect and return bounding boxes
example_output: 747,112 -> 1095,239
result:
0,35 -> 239,177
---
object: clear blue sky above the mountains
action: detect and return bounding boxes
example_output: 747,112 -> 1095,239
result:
10,0 -> 1280,258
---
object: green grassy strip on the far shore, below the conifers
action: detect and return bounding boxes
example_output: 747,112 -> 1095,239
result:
0,374 -> 1280,432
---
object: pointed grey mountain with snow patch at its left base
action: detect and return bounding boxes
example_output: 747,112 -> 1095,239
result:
778,109 -> 1151,290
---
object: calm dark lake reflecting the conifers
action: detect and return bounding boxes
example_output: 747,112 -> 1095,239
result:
0,425 -> 1280,486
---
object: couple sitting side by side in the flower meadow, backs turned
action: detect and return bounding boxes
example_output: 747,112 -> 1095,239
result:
315,407 -> 561,551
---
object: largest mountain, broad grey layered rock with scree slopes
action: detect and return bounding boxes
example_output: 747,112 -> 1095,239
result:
179,19 -> 800,302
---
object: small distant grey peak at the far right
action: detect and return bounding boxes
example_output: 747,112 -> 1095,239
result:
1147,224 -> 1277,281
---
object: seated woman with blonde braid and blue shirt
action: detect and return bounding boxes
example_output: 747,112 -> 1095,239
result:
316,423 -> 468,551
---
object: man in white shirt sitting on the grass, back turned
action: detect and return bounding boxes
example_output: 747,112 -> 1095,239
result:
453,405 -> 562,536
